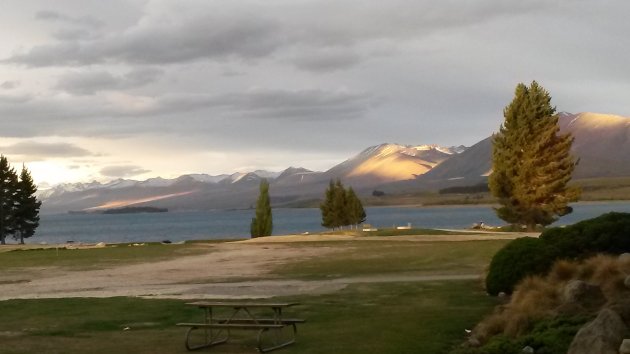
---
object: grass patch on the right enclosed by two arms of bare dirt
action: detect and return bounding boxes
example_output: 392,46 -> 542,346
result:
273,240 -> 509,279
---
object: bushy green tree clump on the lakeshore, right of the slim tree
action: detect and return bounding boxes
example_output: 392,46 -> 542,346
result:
319,179 -> 367,230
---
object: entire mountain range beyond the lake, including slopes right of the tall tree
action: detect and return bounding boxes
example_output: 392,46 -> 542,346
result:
39,113 -> 630,213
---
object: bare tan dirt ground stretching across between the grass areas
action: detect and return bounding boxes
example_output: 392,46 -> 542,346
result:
0,234 -> 540,300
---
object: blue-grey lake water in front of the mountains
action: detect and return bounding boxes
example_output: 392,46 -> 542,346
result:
18,202 -> 630,243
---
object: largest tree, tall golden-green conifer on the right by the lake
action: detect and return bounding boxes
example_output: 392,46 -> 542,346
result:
488,81 -> 580,230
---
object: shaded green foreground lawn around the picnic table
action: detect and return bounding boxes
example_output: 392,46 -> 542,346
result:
0,281 -> 495,354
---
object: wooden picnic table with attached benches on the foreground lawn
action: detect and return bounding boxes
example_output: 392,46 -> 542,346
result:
177,301 -> 306,353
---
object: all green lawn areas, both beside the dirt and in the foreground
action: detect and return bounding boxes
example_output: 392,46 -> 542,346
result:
0,238 -> 509,354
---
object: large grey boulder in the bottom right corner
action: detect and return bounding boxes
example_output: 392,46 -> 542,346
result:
567,309 -> 628,354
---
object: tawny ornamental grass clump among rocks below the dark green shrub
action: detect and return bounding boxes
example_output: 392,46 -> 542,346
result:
455,254 -> 630,354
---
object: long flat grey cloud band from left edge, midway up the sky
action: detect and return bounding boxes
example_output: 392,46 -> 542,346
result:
0,87 -> 379,137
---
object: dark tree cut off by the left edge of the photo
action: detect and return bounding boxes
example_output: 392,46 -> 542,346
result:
0,155 -> 17,245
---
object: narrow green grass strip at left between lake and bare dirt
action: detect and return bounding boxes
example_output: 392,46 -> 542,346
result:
0,243 -> 217,271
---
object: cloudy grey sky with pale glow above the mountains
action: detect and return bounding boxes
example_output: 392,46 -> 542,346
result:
0,0 -> 630,188
